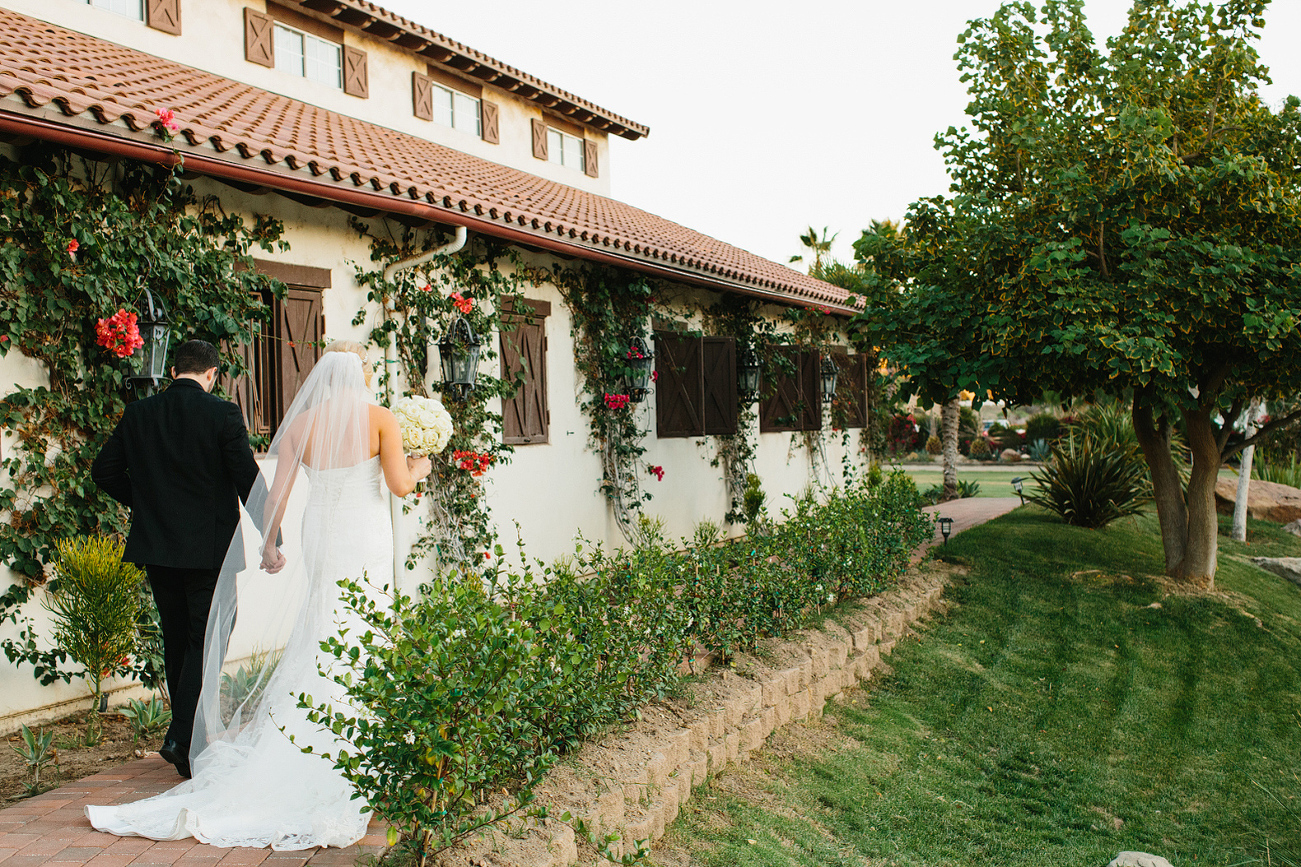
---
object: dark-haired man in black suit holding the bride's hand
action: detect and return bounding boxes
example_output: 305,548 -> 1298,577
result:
91,340 -> 285,777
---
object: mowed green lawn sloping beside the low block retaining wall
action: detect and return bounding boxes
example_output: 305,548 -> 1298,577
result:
652,508 -> 1301,867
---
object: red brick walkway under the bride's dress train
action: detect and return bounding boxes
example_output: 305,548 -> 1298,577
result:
0,755 -> 384,867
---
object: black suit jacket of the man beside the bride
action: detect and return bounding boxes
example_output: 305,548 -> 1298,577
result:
91,379 -> 258,569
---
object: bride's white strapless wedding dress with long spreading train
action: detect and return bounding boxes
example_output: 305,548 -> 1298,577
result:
86,353 -> 393,850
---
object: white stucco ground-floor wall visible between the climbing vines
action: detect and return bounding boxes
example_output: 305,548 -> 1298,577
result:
0,180 -> 857,733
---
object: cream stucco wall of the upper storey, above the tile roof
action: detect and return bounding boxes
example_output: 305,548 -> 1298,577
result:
0,0 -> 610,195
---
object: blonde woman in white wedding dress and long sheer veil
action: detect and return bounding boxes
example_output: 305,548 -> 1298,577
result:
93,341 -> 431,850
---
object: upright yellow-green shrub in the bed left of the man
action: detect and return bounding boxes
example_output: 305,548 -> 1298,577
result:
46,536 -> 144,743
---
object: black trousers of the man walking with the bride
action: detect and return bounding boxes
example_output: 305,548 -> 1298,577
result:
144,565 -> 220,755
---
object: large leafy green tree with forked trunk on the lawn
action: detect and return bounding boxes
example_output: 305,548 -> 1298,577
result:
865,0 -> 1301,586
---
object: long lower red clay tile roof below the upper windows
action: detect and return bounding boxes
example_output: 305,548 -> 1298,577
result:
0,9 -> 847,307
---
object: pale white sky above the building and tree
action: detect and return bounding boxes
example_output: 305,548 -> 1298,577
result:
377,0 -> 1301,267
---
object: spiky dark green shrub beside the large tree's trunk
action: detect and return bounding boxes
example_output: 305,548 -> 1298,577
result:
1025,437 -> 1147,529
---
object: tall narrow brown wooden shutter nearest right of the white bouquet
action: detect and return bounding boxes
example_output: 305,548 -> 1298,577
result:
501,298 -> 550,445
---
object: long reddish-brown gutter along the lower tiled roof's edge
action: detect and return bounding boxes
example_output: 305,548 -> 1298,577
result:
0,111 -> 857,315
